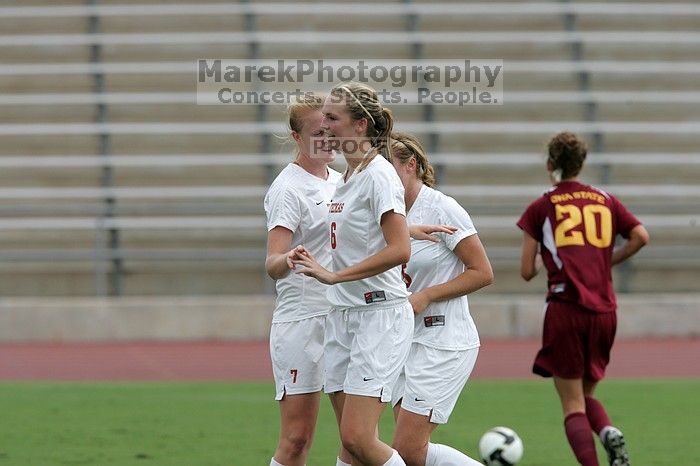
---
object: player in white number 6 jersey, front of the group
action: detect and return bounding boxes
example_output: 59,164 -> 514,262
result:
294,83 -> 413,466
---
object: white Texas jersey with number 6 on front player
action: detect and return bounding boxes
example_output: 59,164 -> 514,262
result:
327,155 -> 410,308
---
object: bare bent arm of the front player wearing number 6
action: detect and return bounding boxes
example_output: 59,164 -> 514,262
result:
293,211 -> 411,285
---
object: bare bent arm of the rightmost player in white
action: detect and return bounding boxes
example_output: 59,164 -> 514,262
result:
409,235 -> 493,314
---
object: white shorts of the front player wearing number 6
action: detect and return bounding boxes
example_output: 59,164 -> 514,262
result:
325,299 -> 413,403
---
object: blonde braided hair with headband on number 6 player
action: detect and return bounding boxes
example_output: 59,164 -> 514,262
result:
330,82 -> 394,172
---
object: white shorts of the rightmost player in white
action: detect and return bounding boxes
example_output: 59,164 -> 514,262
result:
391,343 -> 479,424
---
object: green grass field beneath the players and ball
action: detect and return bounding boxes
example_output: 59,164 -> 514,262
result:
0,380 -> 700,466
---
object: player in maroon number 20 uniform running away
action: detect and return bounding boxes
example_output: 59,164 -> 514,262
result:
518,132 -> 649,466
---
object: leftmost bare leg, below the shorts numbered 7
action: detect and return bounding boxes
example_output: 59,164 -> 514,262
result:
274,392 -> 321,466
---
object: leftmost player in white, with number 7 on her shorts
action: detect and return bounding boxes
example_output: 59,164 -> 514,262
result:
265,95 -> 340,466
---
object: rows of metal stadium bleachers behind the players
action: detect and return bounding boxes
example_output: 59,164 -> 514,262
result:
0,0 -> 700,296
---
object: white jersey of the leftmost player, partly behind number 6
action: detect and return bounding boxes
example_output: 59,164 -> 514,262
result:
265,163 -> 340,323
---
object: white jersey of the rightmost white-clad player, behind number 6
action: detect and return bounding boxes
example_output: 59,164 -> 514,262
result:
404,186 -> 480,350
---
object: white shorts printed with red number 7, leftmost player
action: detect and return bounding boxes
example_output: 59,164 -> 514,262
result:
270,315 -> 326,400
